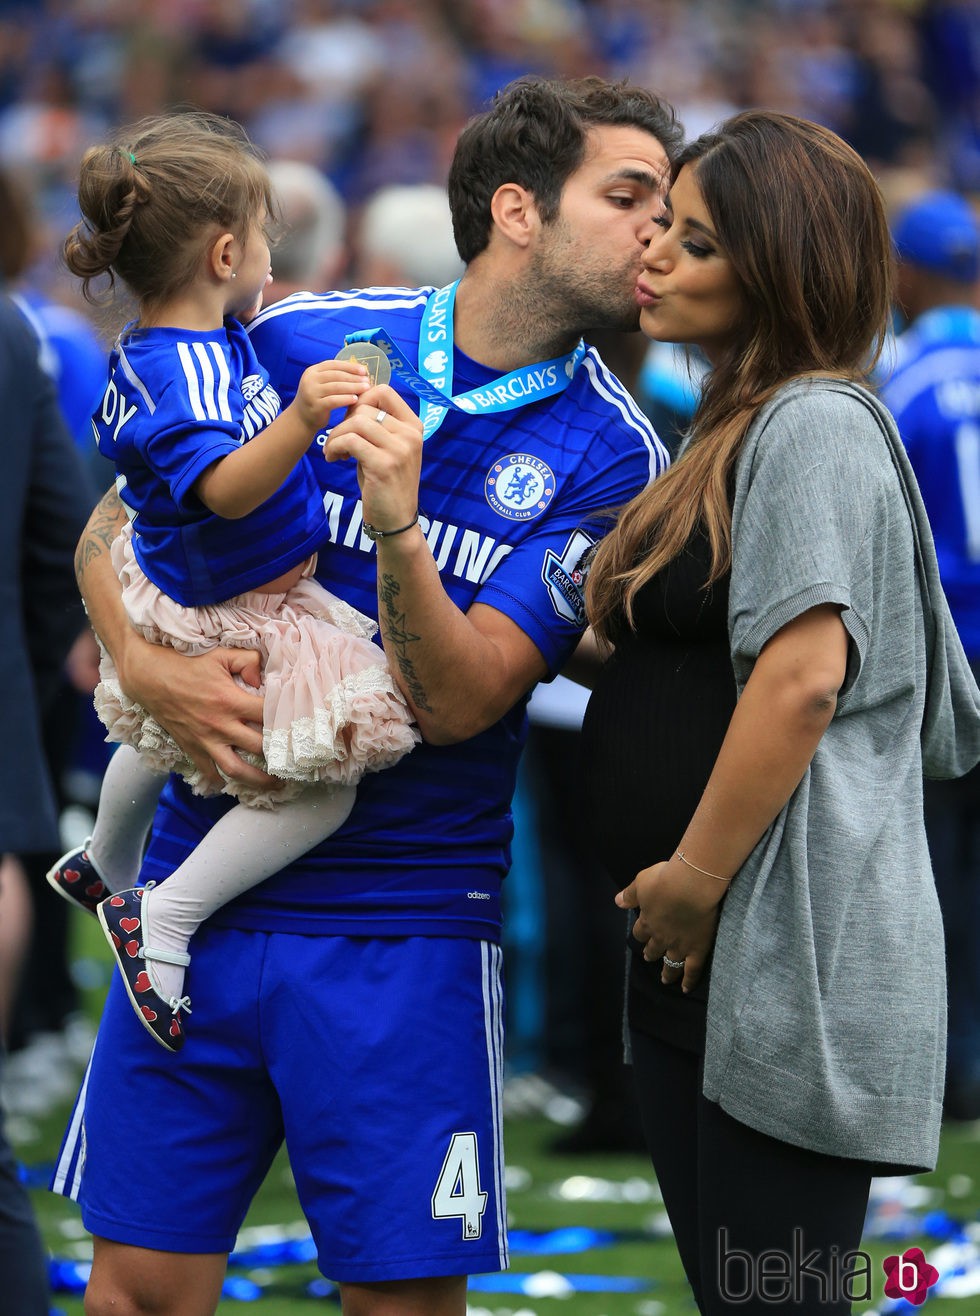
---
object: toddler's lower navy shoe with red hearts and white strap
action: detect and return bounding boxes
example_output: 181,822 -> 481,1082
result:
97,883 -> 191,1051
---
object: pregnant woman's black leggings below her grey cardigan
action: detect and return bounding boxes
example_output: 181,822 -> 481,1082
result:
631,1032 -> 877,1316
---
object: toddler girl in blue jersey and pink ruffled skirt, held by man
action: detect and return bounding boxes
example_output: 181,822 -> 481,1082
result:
47,113 -> 420,1051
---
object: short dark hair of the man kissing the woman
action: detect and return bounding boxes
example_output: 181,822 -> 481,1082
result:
449,78 -> 684,263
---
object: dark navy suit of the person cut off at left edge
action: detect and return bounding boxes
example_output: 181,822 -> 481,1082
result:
0,296 -> 95,1316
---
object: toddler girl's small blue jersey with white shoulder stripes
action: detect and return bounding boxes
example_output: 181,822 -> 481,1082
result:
92,320 -> 324,607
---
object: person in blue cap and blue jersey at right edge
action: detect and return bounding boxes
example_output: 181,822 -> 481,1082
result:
881,192 -> 980,1120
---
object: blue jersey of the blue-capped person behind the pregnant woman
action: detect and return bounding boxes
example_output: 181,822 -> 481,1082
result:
881,307 -> 980,662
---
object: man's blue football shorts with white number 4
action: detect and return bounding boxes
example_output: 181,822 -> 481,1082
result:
51,928 -> 508,1283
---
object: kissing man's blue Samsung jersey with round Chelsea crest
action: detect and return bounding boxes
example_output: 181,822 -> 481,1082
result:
143,288 -> 668,938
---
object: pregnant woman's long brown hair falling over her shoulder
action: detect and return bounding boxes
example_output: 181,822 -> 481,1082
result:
585,111 -> 893,640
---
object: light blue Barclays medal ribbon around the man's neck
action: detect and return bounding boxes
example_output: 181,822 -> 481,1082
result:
343,279 -> 585,438
